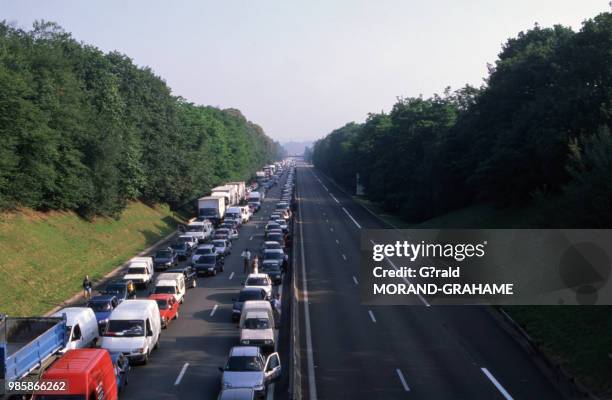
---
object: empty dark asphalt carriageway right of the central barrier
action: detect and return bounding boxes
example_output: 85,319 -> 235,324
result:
294,165 -> 565,400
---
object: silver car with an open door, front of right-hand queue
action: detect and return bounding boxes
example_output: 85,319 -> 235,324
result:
219,346 -> 281,399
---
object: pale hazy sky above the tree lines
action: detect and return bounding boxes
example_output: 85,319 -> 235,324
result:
0,0 -> 610,141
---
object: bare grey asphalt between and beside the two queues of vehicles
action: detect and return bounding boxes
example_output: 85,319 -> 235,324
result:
99,173 -> 290,400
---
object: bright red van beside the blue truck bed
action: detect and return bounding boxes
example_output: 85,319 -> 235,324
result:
33,349 -> 118,400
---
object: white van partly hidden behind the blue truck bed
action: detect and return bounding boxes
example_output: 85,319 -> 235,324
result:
52,307 -> 100,350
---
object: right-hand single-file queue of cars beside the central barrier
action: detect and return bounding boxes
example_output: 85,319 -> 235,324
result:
219,164 -> 294,400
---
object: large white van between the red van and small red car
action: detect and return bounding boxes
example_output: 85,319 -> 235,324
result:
100,300 -> 161,364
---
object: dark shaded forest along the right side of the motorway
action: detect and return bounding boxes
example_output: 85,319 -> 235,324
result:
310,13 -> 612,227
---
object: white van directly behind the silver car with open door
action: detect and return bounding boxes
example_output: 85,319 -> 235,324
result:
239,300 -> 275,352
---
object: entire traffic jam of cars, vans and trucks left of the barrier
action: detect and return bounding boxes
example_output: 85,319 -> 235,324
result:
0,160 -> 295,400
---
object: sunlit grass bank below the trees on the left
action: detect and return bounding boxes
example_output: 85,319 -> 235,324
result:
0,202 -> 179,316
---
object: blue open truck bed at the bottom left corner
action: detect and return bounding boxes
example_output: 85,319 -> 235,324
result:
0,315 -> 67,382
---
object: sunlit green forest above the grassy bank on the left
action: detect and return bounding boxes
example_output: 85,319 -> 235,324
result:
0,22 -> 281,217
